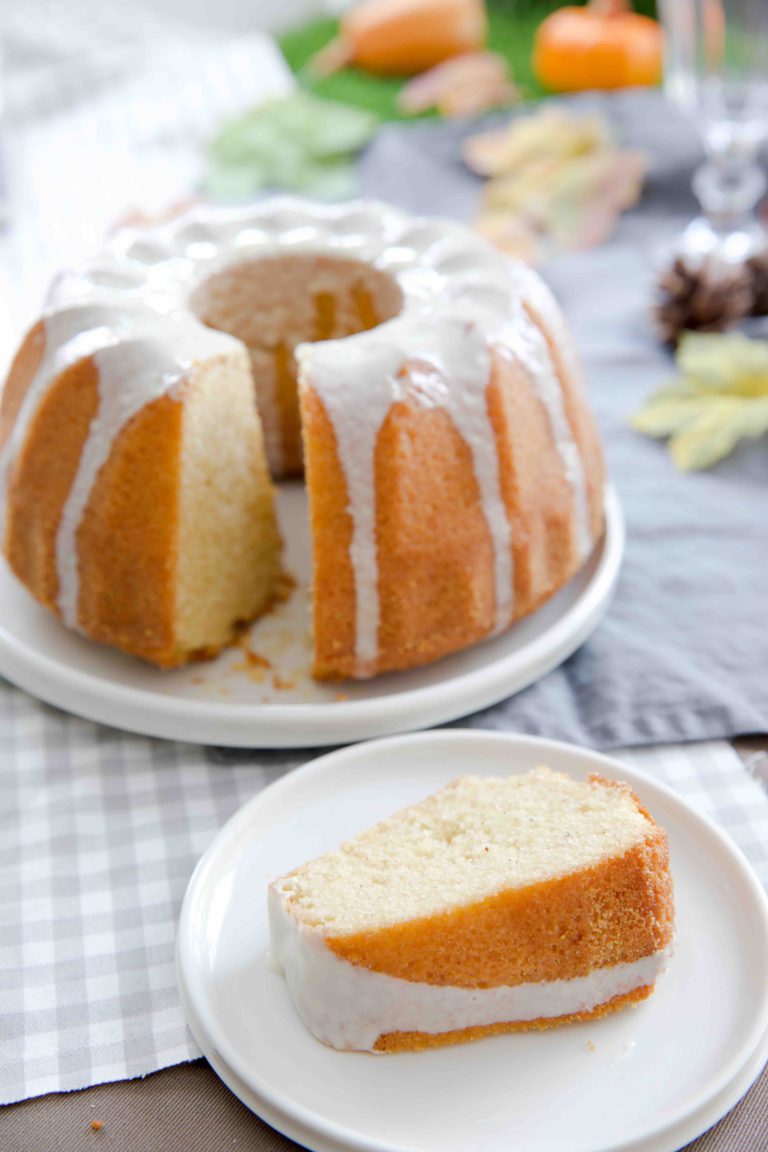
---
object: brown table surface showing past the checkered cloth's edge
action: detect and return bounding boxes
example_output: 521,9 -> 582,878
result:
0,736 -> 768,1152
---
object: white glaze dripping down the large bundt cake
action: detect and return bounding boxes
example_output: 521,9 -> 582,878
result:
0,197 -> 592,658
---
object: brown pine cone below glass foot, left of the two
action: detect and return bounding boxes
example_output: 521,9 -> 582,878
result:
654,256 -> 753,347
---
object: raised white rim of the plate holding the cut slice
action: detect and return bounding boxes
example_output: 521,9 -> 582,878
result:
176,729 -> 768,1152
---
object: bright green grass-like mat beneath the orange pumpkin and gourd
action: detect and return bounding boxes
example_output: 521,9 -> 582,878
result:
277,0 -> 655,120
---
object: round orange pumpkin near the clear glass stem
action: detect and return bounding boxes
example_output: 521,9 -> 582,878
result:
533,0 -> 662,92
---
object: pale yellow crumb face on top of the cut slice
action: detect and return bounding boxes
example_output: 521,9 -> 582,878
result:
280,767 -> 659,937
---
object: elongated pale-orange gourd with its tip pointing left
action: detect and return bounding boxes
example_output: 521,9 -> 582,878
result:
312,0 -> 488,76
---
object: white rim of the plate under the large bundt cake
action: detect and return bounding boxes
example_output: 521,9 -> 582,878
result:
0,485 -> 625,749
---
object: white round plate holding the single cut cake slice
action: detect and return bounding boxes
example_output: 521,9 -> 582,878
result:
177,730 -> 768,1152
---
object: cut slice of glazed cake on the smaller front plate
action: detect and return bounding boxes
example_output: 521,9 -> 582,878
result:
269,767 -> 674,1052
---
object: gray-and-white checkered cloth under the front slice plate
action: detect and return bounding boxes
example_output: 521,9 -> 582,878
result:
0,682 -> 768,1104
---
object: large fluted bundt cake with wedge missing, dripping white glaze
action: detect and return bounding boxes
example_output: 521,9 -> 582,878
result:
0,199 -> 603,677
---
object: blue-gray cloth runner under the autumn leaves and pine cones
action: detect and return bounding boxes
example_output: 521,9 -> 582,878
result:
362,92 -> 768,748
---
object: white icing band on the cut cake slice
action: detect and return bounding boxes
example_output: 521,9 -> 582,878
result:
268,885 -> 668,1052
